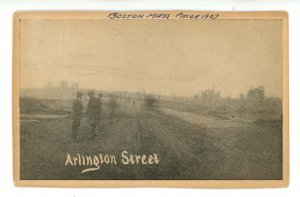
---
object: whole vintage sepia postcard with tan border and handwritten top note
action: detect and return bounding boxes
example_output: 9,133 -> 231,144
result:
13,11 -> 289,188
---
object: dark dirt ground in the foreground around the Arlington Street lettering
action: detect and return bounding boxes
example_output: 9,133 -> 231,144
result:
21,107 -> 282,180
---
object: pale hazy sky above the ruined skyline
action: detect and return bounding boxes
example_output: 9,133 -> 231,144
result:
20,20 -> 282,98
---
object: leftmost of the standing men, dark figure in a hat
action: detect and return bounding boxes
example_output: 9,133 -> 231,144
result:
72,92 -> 83,140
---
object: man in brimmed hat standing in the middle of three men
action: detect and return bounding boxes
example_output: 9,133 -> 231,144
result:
86,91 -> 100,139
